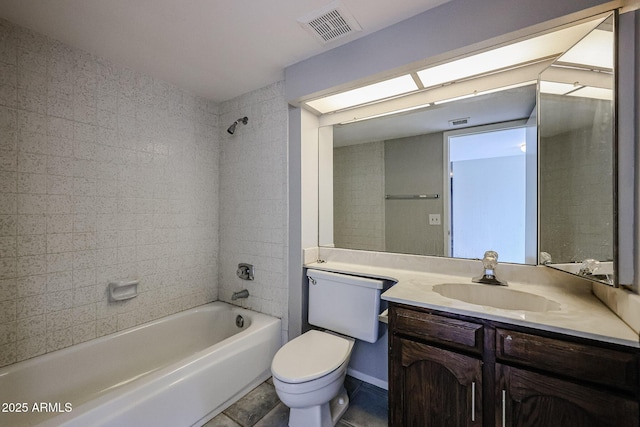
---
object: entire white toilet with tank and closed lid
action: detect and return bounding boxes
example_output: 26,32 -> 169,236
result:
271,270 -> 384,427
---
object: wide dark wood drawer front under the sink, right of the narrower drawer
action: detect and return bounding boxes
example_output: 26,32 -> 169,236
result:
496,328 -> 638,390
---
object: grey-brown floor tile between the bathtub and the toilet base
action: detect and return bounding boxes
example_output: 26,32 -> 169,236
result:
223,383 -> 280,427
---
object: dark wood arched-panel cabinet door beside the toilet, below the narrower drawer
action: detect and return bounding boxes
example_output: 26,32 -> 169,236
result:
389,338 -> 482,427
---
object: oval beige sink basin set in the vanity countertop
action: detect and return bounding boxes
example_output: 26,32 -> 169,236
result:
433,283 -> 560,312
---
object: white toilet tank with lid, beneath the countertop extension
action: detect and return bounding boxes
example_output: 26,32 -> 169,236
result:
307,270 -> 385,343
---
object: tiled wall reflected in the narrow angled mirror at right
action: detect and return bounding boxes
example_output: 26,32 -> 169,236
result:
540,95 -> 613,263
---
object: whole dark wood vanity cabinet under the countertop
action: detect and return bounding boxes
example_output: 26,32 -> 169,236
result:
389,303 -> 640,427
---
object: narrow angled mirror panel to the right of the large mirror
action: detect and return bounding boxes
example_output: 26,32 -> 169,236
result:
538,16 -> 615,284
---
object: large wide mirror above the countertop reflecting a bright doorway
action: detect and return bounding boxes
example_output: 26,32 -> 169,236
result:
322,82 -> 537,264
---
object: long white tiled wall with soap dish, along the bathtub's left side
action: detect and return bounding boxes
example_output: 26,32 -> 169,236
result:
0,20 -> 219,366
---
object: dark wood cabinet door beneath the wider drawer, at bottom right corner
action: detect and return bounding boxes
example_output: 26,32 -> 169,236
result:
495,361 -> 640,427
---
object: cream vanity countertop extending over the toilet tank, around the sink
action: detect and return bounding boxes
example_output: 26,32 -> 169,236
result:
305,261 -> 640,347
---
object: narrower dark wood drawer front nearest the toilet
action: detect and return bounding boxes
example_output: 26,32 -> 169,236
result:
391,308 -> 482,354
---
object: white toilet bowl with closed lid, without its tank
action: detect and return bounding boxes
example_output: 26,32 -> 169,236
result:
271,330 -> 354,427
